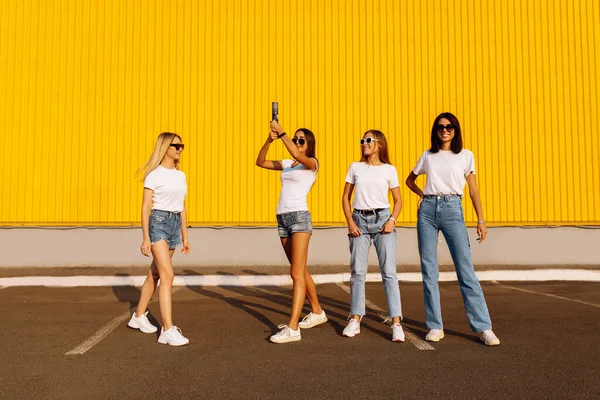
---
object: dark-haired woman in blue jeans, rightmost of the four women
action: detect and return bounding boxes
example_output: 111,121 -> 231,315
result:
406,113 -> 500,346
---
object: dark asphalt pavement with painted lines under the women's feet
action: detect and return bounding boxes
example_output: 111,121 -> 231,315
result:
0,282 -> 600,399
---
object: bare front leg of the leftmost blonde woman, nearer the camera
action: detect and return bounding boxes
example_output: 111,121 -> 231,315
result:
152,240 -> 175,331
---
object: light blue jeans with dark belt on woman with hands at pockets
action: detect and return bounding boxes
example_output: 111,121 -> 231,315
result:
348,209 -> 402,318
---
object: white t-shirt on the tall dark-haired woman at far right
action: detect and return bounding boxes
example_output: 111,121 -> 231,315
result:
413,149 -> 475,196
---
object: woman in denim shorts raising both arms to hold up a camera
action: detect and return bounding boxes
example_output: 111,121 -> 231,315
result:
256,121 -> 327,343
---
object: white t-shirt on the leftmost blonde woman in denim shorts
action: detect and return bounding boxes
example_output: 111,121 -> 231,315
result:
144,165 -> 187,212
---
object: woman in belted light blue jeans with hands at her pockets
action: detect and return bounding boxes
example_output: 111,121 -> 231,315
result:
342,130 -> 404,342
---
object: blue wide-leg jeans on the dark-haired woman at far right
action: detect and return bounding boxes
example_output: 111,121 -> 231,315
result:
417,196 -> 492,332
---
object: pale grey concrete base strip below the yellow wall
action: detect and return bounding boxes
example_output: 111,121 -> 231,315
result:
0,227 -> 600,267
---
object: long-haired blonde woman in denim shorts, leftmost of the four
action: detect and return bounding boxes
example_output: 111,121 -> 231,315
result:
127,132 -> 190,346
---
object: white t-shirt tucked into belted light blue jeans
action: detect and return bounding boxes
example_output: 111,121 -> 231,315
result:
346,162 -> 400,210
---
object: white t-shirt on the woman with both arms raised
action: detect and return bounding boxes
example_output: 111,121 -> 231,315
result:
277,160 -> 319,214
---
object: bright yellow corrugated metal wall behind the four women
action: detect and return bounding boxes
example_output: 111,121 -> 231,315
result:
0,0 -> 600,225
